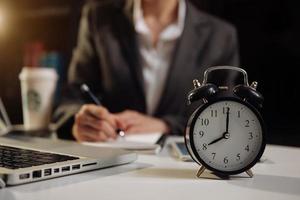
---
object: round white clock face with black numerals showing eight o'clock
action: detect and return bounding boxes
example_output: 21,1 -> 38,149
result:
190,100 -> 265,174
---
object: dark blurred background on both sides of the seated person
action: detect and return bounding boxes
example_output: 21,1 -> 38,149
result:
0,0 -> 300,146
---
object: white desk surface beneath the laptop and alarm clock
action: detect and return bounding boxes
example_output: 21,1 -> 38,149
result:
0,137 -> 300,200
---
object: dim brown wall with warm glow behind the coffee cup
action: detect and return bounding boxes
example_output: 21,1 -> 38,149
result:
0,0 -> 83,123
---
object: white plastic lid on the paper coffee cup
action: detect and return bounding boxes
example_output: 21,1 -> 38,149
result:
19,67 -> 58,80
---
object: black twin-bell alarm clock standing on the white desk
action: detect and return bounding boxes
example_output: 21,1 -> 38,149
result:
185,66 -> 266,177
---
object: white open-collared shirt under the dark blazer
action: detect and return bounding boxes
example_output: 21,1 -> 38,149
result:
133,0 -> 186,115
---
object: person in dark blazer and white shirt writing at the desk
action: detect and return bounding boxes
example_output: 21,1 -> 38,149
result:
57,0 -> 239,141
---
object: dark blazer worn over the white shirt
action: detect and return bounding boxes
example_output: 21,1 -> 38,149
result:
56,0 -> 239,138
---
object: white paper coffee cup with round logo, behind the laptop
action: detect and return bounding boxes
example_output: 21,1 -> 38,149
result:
19,67 -> 58,130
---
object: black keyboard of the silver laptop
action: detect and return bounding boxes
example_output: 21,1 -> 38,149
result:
0,145 -> 79,169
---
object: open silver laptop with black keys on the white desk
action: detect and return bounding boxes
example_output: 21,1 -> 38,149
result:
0,99 -> 137,188
